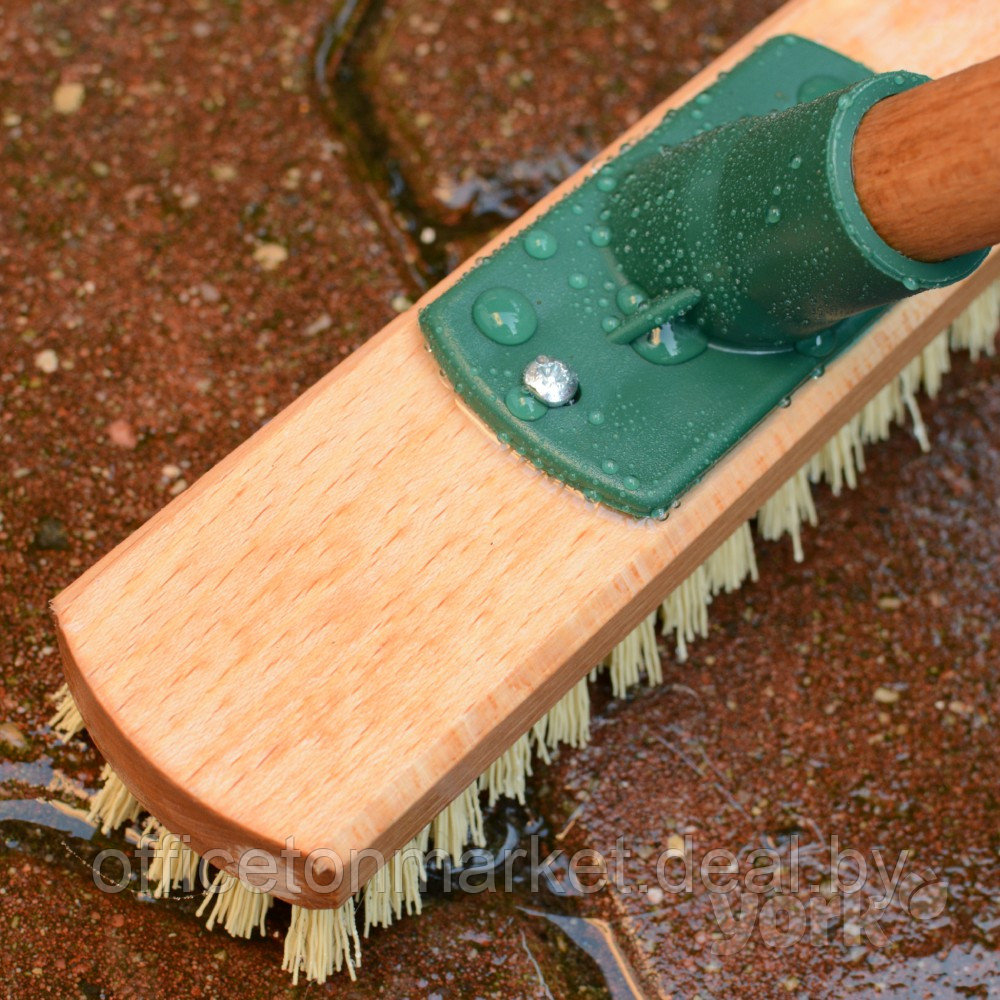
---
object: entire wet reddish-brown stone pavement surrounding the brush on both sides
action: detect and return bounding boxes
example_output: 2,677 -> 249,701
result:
0,0 -> 1000,1000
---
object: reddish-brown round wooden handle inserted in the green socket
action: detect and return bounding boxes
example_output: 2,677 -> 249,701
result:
853,56 -> 1000,261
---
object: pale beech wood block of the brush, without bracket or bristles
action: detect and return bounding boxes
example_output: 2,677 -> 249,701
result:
54,0 -> 1000,906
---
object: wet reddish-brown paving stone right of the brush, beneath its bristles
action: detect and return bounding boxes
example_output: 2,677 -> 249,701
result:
547,352 -> 1000,997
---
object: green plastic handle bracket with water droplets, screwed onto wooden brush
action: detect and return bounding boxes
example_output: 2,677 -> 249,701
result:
420,35 -> 985,518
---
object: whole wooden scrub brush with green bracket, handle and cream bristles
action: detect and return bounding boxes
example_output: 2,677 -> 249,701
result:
47,3 -> 1000,982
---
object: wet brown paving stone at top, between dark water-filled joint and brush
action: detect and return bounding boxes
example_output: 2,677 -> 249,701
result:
334,0 -> 780,262
